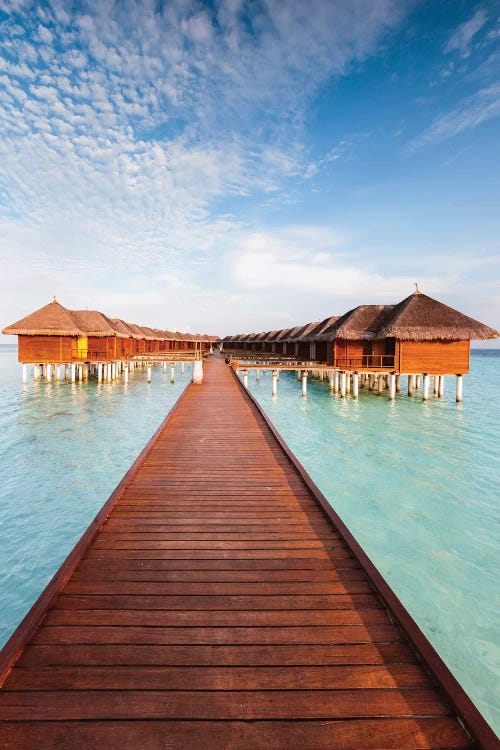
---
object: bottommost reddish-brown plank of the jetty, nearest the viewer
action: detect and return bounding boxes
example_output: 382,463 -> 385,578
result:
2,717 -> 470,750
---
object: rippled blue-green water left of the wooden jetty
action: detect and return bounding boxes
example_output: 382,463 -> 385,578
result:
0,346 -> 190,646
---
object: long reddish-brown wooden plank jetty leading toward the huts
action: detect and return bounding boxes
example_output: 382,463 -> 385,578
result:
0,356 -> 497,750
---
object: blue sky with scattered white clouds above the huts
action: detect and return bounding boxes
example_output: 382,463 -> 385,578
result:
0,0 -> 500,346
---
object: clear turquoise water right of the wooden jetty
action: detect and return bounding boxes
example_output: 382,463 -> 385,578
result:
240,351 -> 500,732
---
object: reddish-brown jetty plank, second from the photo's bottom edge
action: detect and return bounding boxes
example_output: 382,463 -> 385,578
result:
0,688 -> 449,721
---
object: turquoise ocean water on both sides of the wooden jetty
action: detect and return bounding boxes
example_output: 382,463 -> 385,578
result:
0,346 -> 500,731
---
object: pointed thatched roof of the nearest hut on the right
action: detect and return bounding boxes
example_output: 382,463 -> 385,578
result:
377,290 -> 500,341
